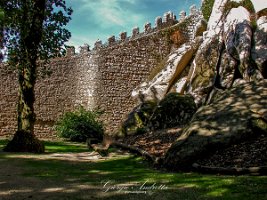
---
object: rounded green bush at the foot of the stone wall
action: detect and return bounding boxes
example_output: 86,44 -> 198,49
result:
55,107 -> 104,142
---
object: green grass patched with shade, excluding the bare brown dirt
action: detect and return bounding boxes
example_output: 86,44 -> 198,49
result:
0,141 -> 267,200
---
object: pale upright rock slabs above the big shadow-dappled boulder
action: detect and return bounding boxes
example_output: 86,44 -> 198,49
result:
132,0 -> 267,106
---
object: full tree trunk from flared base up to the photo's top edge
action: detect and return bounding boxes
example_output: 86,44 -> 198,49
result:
4,0 -> 46,153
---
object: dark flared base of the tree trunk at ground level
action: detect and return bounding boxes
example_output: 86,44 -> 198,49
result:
4,130 -> 45,153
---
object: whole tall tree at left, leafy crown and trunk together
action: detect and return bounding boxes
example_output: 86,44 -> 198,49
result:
0,0 -> 72,153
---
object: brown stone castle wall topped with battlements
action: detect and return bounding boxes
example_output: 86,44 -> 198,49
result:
0,7 -> 201,138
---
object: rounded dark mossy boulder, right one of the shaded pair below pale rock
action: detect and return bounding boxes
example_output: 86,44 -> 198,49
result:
149,93 -> 197,130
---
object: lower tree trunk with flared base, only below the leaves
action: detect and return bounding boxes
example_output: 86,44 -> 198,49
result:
4,62 -> 44,153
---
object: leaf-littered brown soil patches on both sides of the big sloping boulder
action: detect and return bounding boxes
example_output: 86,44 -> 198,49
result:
122,128 -> 267,168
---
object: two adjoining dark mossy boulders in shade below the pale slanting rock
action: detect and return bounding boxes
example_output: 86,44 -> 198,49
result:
120,93 -> 197,136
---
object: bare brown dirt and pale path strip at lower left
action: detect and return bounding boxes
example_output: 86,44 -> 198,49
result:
0,152 -> 131,200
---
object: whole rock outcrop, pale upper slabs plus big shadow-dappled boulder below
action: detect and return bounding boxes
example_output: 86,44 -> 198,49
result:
129,0 -> 267,169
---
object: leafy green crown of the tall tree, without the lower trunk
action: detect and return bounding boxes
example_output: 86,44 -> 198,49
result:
0,0 -> 72,64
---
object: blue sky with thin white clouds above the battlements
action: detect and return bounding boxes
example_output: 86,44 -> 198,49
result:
66,0 -> 201,49
